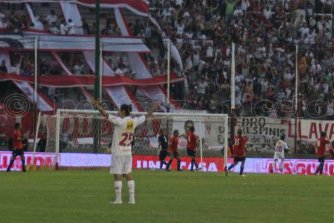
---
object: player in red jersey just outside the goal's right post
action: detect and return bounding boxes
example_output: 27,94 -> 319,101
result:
225,129 -> 248,176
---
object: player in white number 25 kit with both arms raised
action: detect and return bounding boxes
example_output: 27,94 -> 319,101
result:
92,101 -> 153,204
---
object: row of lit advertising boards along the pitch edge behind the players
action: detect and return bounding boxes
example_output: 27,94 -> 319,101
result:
0,152 -> 334,176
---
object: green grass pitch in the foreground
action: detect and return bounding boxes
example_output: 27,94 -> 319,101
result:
0,170 -> 334,223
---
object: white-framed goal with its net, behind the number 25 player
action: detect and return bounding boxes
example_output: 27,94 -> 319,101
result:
37,109 -> 228,171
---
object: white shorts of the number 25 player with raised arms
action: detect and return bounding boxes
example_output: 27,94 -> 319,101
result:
110,155 -> 132,175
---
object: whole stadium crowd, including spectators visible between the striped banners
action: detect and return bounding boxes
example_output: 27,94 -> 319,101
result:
0,0 -> 334,117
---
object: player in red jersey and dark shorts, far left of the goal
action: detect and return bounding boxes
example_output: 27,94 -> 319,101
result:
7,123 -> 26,172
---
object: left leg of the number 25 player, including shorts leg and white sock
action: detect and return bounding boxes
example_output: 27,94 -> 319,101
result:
110,155 -> 123,204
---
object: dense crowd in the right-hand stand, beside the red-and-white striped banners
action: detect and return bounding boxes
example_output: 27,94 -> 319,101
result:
151,0 -> 334,117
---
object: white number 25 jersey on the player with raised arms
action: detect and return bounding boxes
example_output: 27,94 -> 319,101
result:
108,115 -> 145,155
